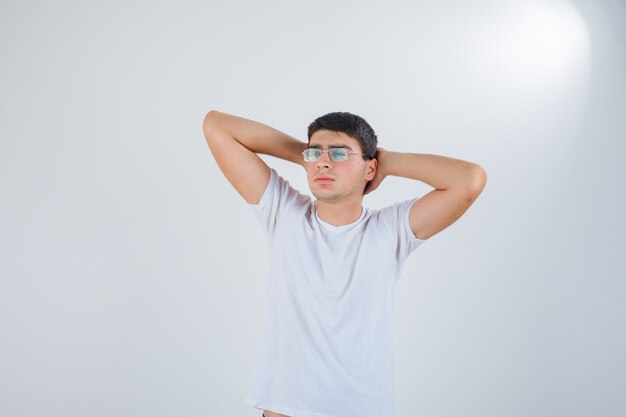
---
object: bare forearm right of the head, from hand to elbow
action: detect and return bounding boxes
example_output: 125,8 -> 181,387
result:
379,151 -> 486,192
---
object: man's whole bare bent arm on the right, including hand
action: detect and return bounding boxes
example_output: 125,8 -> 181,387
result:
365,148 -> 487,239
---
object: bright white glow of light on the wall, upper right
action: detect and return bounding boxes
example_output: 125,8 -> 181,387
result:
474,0 -> 590,91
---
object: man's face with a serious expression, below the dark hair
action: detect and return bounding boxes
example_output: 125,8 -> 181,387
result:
305,130 -> 377,203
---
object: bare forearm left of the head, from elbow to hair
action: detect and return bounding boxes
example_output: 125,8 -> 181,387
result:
204,110 -> 307,165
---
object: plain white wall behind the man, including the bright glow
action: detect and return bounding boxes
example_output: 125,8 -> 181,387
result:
0,0 -> 626,417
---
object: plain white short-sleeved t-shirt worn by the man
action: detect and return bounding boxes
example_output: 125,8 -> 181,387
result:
245,168 -> 425,417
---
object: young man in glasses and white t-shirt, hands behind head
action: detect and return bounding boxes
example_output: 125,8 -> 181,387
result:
203,110 -> 487,417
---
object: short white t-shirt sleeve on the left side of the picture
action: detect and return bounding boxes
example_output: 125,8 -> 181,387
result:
246,168 -> 303,240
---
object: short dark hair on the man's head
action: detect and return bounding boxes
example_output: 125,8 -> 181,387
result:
308,112 -> 378,160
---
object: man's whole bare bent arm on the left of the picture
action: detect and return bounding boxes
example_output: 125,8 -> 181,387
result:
203,110 -> 307,204
